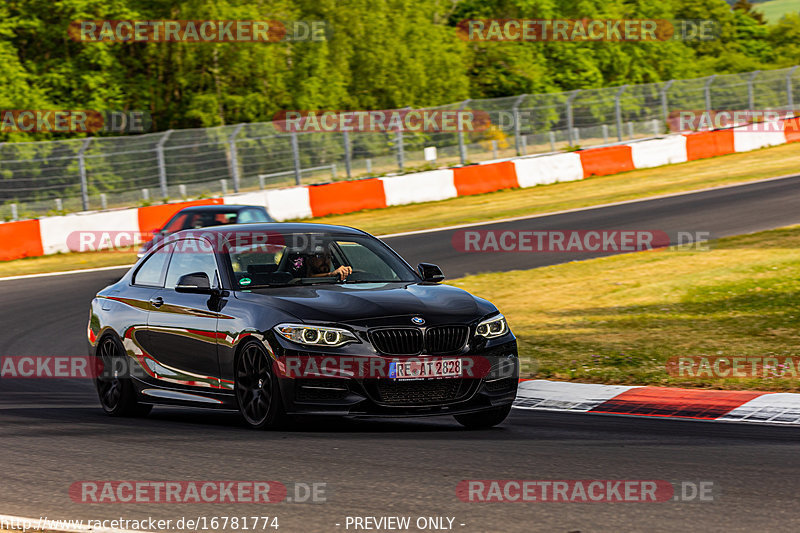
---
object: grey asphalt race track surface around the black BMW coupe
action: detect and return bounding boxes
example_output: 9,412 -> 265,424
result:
0,177 -> 800,532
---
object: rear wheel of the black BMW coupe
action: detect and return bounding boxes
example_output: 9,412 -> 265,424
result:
94,335 -> 153,417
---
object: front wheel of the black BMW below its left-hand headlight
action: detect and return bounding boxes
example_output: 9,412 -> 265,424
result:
234,341 -> 286,429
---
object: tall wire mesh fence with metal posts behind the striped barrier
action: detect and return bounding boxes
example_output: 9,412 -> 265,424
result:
0,66 -> 800,220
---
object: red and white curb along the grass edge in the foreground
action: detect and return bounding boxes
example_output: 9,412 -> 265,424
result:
514,380 -> 800,426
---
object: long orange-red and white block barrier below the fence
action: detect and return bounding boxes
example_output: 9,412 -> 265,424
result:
0,118 -> 800,261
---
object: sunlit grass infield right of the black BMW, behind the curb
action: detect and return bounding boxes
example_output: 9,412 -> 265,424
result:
451,226 -> 800,391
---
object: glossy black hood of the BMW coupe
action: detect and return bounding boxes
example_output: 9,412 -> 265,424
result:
236,283 -> 496,325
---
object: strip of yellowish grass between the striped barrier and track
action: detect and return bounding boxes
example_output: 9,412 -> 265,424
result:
0,139 -> 800,277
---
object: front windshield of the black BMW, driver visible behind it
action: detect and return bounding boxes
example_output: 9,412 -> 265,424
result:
225,232 -> 416,289
